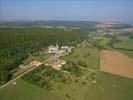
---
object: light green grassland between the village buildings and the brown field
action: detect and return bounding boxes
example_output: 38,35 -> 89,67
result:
63,42 -> 99,70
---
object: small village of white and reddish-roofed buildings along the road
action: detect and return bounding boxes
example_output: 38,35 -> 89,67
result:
19,44 -> 73,70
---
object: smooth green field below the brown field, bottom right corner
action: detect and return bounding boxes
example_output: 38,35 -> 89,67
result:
83,72 -> 133,100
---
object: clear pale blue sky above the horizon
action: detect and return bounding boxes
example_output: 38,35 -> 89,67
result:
0,0 -> 133,22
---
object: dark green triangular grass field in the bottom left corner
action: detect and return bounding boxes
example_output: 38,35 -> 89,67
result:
0,80 -> 64,100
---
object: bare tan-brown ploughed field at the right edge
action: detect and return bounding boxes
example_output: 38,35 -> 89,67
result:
100,50 -> 133,78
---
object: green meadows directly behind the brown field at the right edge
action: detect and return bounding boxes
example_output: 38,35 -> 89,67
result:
113,31 -> 133,58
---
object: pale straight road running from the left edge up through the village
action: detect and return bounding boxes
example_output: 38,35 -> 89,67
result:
0,54 -> 66,89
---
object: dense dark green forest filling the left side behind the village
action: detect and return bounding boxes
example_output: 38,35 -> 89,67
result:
0,28 -> 86,84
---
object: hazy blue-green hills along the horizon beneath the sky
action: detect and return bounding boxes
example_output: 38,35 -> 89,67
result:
0,20 -> 100,30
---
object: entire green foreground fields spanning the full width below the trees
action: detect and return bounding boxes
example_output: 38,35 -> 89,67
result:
0,72 -> 133,100
